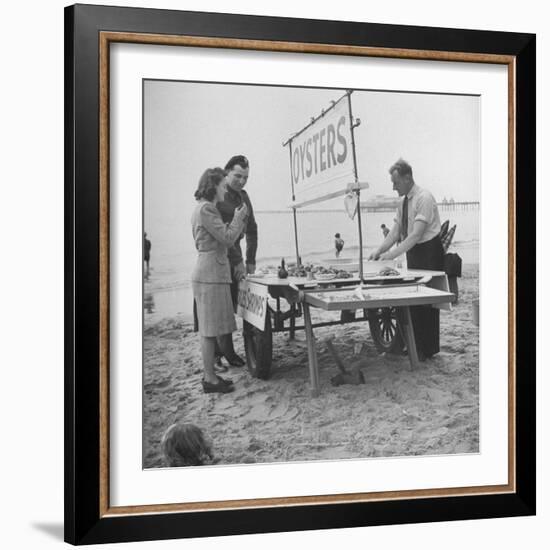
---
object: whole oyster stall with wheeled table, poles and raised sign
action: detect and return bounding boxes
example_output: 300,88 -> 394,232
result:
237,91 -> 454,396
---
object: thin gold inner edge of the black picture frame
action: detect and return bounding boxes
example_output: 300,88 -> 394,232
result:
99,31 -> 516,517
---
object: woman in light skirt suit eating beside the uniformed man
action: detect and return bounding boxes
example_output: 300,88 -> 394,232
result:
191,168 -> 248,393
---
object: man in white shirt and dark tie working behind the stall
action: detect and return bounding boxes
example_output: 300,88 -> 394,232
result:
369,159 -> 444,360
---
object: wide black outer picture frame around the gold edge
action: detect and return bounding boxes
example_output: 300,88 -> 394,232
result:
65,5 -> 536,544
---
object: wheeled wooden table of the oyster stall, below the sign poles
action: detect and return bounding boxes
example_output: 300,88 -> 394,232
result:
239,270 -> 454,395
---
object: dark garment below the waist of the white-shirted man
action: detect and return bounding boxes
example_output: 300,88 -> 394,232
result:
407,235 -> 445,357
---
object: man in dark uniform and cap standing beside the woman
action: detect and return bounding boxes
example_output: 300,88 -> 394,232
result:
217,155 -> 258,366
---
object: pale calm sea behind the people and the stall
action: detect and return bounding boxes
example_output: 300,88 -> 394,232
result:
144,205 -> 479,322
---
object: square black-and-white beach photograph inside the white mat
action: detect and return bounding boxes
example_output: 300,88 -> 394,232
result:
142,78 -> 480,469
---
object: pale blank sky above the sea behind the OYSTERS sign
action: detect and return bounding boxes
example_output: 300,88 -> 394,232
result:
144,80 -> 480,236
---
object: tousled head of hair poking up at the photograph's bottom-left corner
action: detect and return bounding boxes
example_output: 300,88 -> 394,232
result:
160,422 -> 213,466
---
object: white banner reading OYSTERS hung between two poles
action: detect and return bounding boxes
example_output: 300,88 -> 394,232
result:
289,95 -> 355,205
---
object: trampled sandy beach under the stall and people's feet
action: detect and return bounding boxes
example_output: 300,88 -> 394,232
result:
143,264 -> 479,468
